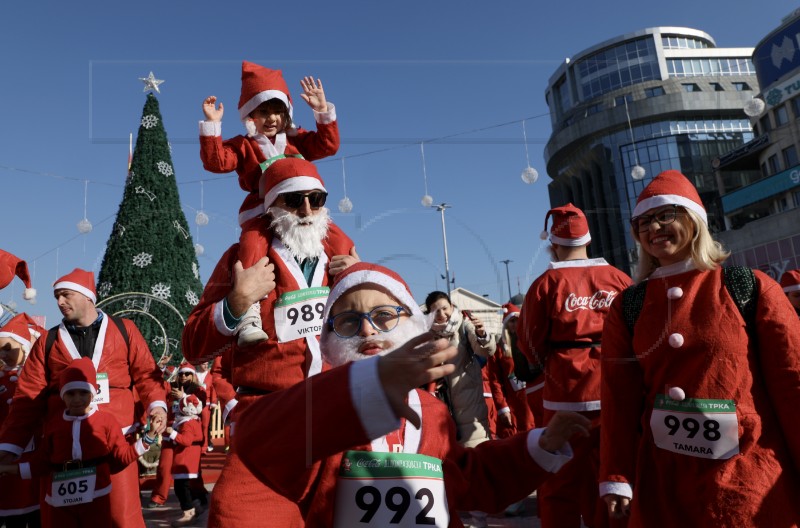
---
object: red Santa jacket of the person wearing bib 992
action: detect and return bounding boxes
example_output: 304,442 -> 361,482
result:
234,365 -> 566,528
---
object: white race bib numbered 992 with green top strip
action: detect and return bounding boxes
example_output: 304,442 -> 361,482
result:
333,451 -> 450,528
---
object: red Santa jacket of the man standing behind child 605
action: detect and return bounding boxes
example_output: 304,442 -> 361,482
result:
0,316 -> 167,454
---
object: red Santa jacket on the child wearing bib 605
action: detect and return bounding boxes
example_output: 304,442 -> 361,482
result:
19,406 -> 147,504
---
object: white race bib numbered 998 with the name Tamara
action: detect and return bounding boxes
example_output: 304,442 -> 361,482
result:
650,394 -> 739,460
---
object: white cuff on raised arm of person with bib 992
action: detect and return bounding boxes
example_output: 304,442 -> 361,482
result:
350,356 -> 400,439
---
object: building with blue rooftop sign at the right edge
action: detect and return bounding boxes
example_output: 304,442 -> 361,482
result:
715,10 -> 800,280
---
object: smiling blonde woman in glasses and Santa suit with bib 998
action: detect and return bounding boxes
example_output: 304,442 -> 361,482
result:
600,170 -> 800,528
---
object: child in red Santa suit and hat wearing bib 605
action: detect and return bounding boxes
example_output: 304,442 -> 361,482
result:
0,357 -> 163,528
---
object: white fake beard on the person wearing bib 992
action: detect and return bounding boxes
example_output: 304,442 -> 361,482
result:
320,317 -> 427,367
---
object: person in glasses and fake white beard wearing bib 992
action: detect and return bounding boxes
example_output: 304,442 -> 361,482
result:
234,262 -> 589,528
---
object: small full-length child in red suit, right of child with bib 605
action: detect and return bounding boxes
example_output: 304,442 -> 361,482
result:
166,394 -> 205,526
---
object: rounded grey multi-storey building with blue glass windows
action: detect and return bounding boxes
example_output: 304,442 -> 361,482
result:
545,27 -> 758,271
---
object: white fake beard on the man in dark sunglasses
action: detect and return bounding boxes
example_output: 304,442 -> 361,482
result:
267,207 -> 331,261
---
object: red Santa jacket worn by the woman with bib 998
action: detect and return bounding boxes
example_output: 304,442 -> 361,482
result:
600,263 -> 800,528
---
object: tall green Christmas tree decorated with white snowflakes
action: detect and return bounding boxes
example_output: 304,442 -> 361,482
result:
97,85 -> 203,364
